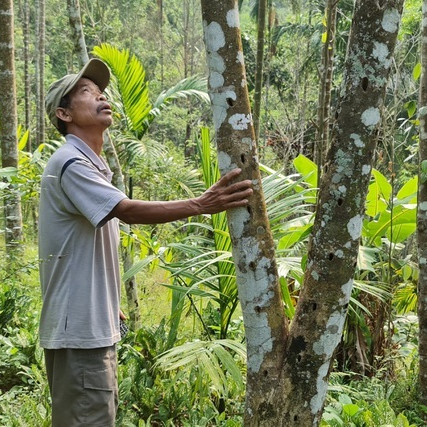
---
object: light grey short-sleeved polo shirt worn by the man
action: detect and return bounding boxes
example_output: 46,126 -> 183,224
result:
39,135 -> 126,349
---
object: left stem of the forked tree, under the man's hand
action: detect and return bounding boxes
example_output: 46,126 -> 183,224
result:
202,0 -> 287,425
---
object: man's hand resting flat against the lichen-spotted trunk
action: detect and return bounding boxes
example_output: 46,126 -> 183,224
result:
195,169 -> 253,214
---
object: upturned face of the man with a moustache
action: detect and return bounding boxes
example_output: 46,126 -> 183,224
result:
61,77 -> 113,130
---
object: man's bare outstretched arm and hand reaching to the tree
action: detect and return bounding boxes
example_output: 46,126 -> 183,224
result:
107,169 -> 252,224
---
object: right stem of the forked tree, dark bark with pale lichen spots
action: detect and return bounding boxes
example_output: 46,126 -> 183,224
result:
274,0 -> 403,426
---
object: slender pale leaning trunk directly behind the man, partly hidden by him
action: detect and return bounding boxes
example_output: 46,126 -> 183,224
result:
67,0 -> 140,329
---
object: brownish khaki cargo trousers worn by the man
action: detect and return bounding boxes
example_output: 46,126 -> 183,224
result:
45,345 -> 118,427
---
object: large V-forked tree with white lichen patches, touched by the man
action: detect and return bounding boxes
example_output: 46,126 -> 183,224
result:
202,0 -> 403,426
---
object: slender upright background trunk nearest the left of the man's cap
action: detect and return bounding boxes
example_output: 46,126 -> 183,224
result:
36,0 -> 46,145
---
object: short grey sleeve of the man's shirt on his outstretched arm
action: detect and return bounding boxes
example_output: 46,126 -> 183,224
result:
61,159 -> 127,227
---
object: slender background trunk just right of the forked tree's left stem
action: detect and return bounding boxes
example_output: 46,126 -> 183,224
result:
254,0 -> 267,143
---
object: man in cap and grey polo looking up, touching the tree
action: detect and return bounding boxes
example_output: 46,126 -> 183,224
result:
39,59 -> 252,427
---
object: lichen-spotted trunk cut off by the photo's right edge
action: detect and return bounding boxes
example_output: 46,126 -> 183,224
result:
417,0 -> 427,423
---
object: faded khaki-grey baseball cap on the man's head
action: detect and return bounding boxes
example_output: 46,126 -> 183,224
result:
46,58 -> 110,129
